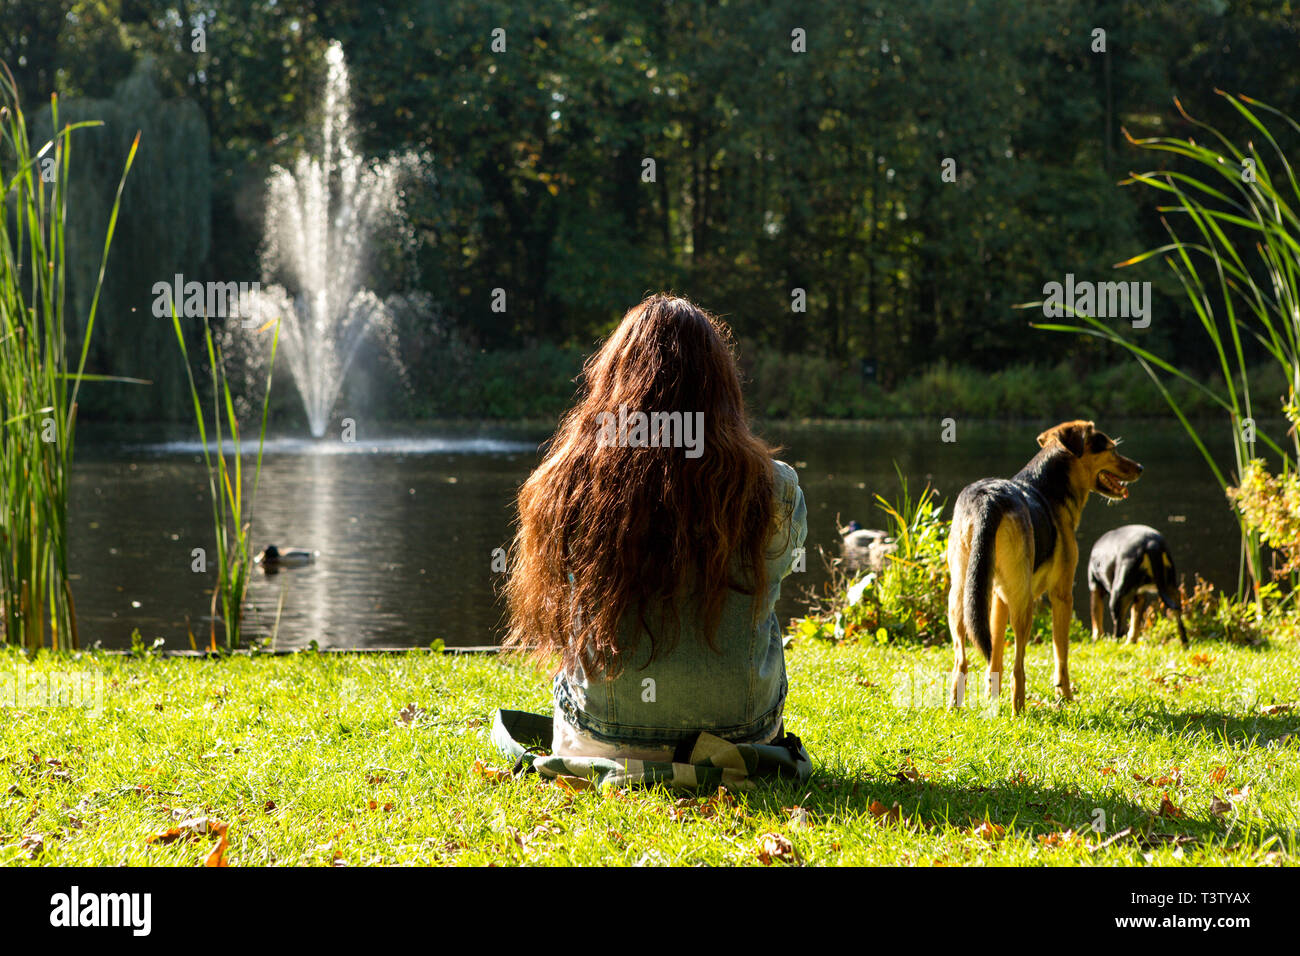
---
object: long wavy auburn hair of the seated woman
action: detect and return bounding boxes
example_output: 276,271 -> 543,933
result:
504,294 -> 777,676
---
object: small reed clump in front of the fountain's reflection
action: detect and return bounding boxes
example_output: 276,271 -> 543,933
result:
172,312 -> 280,650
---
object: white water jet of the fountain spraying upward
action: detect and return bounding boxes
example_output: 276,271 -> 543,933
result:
257,40 -> 420,437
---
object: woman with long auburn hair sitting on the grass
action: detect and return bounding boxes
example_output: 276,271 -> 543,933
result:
506,295 -> 807,763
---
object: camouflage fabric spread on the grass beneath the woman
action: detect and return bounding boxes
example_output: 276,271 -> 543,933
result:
491,710 -> 813,790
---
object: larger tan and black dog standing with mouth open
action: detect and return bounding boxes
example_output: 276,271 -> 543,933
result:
948,421 -> 1141,714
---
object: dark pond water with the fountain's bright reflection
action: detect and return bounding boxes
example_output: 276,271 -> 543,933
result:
69,420 -> 1239,648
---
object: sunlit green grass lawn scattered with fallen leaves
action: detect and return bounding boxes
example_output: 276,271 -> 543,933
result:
0,640 -> 1300,866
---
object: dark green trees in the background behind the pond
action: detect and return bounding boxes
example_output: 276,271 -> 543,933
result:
0,0 -> 1300,418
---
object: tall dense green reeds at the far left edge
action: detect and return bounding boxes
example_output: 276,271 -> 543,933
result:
0,68 -> 139,649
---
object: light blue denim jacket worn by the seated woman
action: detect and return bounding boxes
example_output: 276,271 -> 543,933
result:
554,462 -> 807,748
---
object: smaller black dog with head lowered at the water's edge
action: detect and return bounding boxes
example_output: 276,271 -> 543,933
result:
1088,524 -> 1187,648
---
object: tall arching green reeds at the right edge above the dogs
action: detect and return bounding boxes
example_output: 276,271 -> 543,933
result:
1024,90 -> 1300,596
